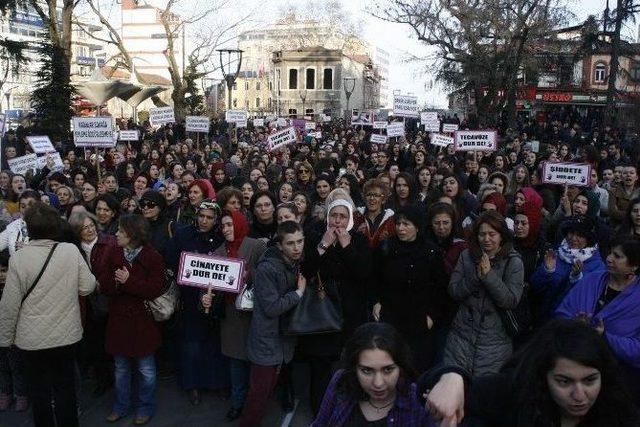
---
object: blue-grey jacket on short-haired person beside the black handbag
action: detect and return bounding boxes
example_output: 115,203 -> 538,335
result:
247,246 -> 300,366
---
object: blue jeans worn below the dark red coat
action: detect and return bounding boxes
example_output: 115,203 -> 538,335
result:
113,354 -> 156,417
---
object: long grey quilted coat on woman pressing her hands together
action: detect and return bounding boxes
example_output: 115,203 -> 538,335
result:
444,249 -> 524,377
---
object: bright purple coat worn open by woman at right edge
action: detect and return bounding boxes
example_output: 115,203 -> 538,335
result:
556,271 -> 640,372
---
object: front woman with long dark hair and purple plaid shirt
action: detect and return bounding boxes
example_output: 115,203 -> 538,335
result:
311,323 -> 431,427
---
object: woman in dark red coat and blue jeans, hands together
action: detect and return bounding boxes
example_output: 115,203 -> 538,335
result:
98,215 -> 165,425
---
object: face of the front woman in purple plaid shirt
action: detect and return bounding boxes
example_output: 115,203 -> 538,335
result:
356,348 -> 400,402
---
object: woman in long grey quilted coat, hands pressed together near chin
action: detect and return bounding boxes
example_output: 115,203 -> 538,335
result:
444,211 -> 524,378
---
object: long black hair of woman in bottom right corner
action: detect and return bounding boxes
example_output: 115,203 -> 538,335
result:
507,319 -> 637,427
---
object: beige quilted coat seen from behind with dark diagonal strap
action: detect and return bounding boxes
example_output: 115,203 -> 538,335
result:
0,240 -> 96,350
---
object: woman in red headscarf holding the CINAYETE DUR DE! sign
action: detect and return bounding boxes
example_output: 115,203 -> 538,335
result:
203,211 -> 267,421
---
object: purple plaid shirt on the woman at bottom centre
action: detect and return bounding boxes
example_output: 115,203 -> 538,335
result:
311,369 -> 436,427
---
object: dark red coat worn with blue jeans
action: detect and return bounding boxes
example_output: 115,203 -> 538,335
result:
98,245 -> 165,357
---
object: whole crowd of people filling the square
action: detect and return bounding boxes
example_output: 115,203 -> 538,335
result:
0,114 -> 640,427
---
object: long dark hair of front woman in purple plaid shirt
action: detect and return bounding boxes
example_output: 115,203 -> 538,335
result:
337,322 -> 415,400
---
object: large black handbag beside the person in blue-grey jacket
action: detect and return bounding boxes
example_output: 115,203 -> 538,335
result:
285,273 -> 344,335
